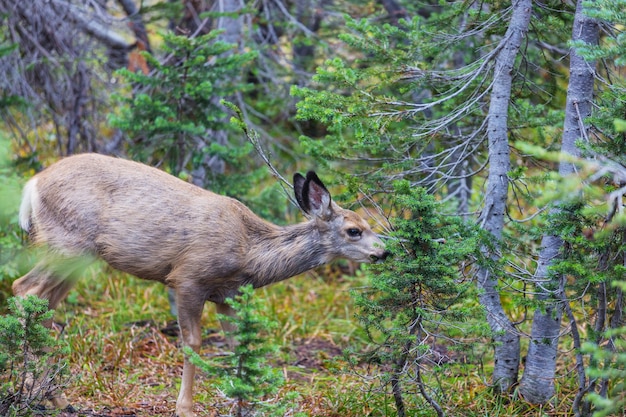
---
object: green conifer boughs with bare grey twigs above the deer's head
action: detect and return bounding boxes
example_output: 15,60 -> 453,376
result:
291,2 -> 569,200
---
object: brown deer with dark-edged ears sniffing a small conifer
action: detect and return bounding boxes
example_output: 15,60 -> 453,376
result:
13,153 -> 389,417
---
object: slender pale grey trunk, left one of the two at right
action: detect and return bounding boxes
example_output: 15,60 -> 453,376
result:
478,0 -> 532,392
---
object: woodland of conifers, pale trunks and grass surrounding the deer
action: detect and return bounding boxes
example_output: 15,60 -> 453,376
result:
0,0 -> 626,416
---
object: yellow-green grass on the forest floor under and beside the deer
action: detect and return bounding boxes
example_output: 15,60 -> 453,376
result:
20,266 -> 574,417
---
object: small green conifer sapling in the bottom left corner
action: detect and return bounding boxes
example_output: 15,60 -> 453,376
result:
0,295 -> 67,416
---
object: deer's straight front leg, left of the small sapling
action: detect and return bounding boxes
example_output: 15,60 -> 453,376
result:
176,289 -> 204,417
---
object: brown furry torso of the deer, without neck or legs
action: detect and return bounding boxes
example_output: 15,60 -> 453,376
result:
32,154 -> 254,280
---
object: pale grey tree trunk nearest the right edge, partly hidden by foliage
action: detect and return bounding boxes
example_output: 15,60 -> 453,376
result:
520,0 -> 599,404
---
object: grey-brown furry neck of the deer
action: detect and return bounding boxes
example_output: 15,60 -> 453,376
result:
245,221 -> 333,288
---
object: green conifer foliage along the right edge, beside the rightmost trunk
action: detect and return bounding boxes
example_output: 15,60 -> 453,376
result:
526,123 -> 626,416
